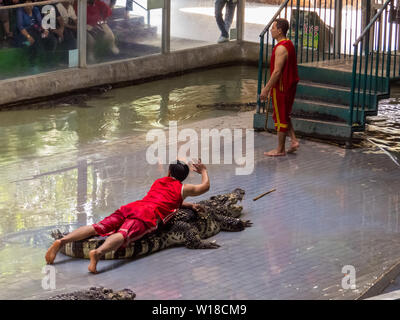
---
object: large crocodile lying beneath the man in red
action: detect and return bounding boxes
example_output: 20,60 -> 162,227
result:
51,188 -> 252,260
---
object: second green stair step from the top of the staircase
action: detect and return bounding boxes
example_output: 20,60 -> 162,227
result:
296,80 -> 378,111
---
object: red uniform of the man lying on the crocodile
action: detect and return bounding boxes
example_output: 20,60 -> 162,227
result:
93,177 -> 183,242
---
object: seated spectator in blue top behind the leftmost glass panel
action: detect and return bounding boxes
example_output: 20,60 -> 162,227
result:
15,0 -> 57,58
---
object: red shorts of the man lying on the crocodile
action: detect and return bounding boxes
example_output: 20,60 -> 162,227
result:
93,210 -> 157,243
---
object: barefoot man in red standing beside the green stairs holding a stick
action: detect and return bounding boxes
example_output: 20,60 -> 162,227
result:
260,19 -> 299,157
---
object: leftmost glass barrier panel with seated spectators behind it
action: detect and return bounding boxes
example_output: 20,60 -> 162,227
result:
0,0 -> 79,80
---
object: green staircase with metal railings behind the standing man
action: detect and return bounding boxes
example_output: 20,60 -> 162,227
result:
253,0 -> 400,144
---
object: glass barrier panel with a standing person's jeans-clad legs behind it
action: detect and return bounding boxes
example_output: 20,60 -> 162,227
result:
171,0 -> 237,51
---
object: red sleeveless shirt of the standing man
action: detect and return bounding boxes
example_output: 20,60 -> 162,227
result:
270,39 -> 299,92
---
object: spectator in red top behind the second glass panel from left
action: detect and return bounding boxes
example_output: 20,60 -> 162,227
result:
75,0 -> 119,63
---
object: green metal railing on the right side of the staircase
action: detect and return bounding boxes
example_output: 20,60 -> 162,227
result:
349,0 -> 400,128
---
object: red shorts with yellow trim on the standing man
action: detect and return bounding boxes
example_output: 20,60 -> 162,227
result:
272,87 -> 296,132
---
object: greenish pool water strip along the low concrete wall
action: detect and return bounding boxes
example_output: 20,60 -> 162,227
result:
0,66 -> 257,166
